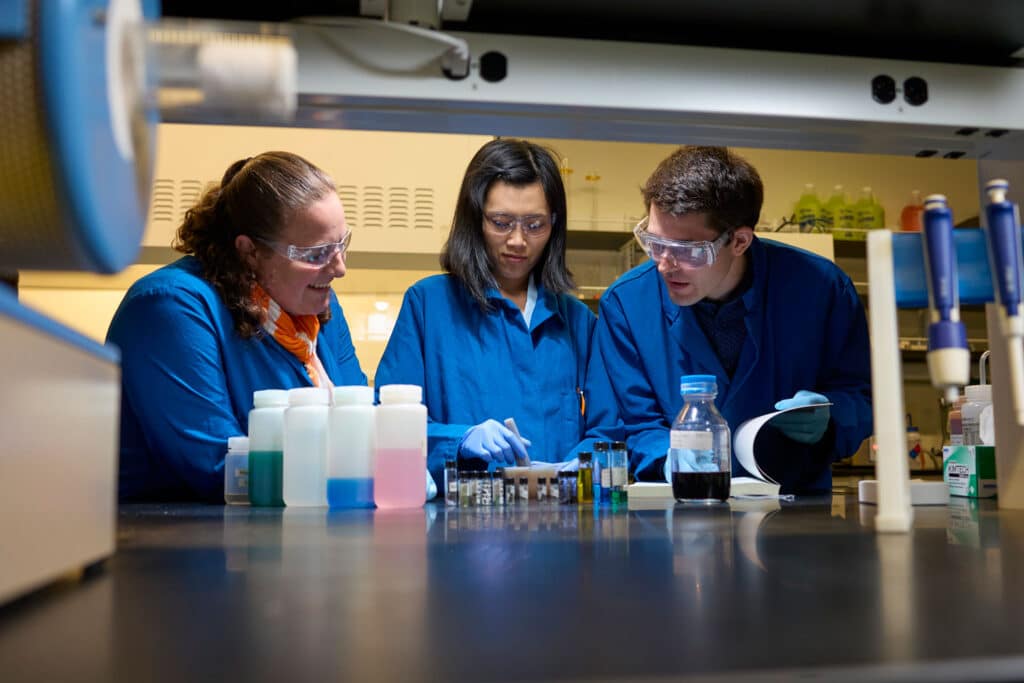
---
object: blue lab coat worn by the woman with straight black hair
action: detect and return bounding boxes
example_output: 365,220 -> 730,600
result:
374,274 -> 614,489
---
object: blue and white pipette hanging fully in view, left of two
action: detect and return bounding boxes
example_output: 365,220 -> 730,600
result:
922,195 -> 971,403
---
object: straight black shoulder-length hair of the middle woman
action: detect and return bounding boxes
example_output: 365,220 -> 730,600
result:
440,138 -> 575,310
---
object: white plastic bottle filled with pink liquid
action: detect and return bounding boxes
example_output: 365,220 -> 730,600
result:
374,384 -> 427,508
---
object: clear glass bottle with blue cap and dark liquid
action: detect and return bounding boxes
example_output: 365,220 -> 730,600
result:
669,375 -> 732,503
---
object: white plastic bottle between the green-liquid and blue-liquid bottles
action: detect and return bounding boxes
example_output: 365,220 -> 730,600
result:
282,387 -> 331,507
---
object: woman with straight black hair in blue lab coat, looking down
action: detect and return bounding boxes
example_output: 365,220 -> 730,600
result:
375,139 -> 607,491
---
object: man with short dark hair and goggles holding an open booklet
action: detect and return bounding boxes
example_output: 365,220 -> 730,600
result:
595,146 -> 871,493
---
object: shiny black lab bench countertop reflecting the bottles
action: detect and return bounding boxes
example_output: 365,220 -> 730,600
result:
0,494 -> 1024,683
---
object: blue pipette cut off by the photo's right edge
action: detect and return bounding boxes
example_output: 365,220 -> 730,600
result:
985,179 -> 1024,425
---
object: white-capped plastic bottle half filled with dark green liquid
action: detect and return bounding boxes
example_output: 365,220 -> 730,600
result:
249,389 -> 288,508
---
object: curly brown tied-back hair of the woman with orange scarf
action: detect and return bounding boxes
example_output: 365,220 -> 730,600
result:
172,152 -> 337,339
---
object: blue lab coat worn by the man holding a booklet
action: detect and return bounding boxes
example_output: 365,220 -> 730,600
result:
595,238 -> 871,493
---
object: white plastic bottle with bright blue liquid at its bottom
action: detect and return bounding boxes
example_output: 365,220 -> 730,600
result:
327,386 -> 377,508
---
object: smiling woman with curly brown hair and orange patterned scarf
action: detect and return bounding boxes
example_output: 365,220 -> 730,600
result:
106,152 -> 367,501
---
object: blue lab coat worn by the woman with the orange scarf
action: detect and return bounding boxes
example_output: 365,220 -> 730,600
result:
106,256 -> 367,502
